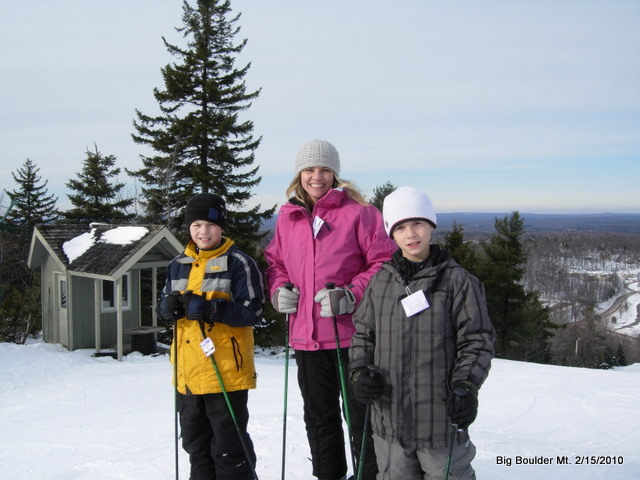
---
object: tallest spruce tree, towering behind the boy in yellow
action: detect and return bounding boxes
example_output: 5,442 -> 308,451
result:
129,0 -> 275,248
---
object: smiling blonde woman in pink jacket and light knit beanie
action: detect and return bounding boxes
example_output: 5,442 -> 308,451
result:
265,139 -> 395,480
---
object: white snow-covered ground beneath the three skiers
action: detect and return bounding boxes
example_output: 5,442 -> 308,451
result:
0,341 -> 640,480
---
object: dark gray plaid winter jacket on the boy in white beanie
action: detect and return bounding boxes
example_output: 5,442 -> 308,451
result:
349,245 -> 495,448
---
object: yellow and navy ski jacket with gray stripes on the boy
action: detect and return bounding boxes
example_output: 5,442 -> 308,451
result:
160,238 -> 265,395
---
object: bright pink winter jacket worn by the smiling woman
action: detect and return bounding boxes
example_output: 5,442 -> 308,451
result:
264,189 -> 397,350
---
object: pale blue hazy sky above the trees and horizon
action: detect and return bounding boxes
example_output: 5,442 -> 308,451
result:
0,0 -> 640,213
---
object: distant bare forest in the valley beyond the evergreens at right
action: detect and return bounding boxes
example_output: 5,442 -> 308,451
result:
433,225 -> 640,363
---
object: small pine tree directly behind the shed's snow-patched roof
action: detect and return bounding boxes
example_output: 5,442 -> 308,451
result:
62,145 -> 134,223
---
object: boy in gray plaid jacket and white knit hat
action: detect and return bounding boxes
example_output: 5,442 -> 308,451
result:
349,187 -> 495,480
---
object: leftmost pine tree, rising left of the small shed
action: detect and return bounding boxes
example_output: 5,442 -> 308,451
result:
6,158 -> 59,233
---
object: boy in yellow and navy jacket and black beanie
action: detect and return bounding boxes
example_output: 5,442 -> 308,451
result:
159,193 -> 264,480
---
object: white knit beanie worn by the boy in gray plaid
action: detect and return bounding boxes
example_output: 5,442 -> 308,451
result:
382,187 -> 437,237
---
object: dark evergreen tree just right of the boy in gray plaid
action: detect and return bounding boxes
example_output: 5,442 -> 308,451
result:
478,212 -> 554,362
